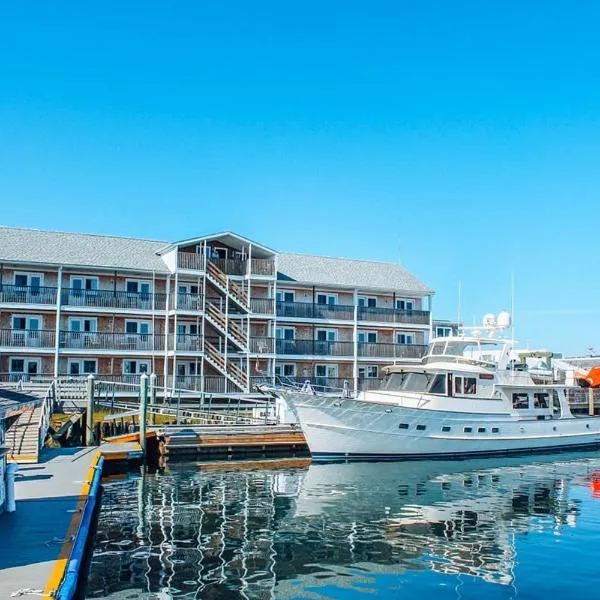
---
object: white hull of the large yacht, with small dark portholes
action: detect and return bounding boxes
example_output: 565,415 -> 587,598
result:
282,392 -> 600,461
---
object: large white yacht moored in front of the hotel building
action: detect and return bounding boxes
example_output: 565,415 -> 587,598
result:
277,313 -> 600,460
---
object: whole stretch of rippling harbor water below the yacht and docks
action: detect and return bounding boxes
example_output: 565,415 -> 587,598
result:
88,454 -> 600,600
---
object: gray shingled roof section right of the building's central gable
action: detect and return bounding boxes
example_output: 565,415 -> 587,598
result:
277,253 -> 433,294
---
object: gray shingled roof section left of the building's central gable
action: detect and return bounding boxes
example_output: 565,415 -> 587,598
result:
0,227 -> 168,272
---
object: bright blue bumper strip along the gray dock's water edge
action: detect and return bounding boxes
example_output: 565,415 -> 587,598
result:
55,456 -> 104,600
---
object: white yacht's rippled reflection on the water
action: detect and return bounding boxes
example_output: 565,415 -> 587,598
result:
282,454 -> 600,584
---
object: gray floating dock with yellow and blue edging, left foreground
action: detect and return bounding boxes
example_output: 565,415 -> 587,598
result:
0,442 -> 141,600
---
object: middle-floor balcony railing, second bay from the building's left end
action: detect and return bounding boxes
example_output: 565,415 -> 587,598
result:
59,331 -> 165,352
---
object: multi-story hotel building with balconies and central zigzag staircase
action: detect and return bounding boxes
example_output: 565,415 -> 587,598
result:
0,227 -> 433,395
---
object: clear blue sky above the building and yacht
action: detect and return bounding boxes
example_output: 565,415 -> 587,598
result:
0,0 -> 600,353
